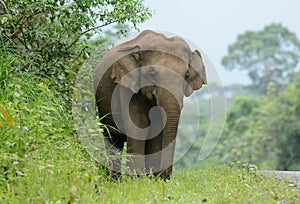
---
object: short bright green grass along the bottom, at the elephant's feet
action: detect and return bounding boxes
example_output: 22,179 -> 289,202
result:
0,155 -> 300,203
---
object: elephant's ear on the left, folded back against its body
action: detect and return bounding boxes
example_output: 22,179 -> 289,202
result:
111,45 -> 140,93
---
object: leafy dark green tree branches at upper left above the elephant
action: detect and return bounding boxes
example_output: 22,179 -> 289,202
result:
0,0 -> 151,91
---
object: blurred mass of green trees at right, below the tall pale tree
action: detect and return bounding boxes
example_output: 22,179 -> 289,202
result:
217,73 -> 300,170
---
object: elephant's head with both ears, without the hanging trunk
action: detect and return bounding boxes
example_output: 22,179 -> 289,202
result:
111,34 -> 207,108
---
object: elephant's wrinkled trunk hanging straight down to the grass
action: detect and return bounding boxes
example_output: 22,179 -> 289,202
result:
156,90 -> 182,179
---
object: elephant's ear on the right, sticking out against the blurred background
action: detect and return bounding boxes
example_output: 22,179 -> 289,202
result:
184,50 -> 207,96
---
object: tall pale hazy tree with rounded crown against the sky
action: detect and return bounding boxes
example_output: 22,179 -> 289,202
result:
222,23 -> 300,94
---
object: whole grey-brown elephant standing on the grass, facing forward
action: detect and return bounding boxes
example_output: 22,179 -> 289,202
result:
94,30 -> 206,179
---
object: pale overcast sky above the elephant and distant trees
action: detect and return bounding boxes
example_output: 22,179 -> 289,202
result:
140,0 -> 300,85
